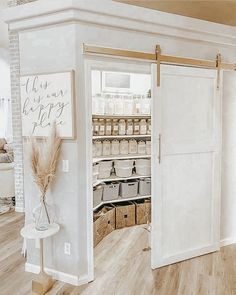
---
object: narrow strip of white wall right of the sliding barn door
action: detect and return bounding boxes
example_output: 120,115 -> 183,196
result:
221,72 -> 236,244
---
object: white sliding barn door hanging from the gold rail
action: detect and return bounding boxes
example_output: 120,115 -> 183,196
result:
152,65 -> 221,268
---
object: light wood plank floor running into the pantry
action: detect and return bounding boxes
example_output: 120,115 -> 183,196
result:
0,212 -> 236,295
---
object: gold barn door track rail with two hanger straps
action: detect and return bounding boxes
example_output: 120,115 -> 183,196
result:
83,44 -> 236,89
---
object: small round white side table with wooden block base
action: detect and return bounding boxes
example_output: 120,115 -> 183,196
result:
20,223 -> 60,295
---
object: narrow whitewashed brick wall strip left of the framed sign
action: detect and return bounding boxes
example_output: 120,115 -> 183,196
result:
8,0 -> 36,211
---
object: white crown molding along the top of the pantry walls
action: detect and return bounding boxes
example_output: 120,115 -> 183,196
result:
2,0 -> 236,47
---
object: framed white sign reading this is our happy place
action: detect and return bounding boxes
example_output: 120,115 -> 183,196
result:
20,71 -> 75,139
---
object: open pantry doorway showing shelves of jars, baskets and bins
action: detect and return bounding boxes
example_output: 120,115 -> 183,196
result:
86,59 -> 152,282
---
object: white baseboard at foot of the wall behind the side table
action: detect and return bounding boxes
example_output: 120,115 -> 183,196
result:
25,263 -> 90,286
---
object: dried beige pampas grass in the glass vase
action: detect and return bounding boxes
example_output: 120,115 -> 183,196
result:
31,123 -> 61,201
